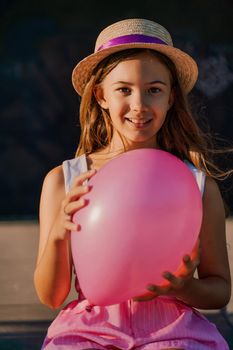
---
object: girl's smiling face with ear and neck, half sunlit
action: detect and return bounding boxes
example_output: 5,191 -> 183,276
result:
95,52 -> 173,148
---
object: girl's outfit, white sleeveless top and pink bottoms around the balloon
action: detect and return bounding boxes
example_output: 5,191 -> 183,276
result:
42,156 -> 229,350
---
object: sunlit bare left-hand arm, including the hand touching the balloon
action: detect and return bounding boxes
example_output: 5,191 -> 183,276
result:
34,166 -> 93,308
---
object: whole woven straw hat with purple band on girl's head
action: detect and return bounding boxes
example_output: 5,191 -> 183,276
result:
72,18 -> 198,95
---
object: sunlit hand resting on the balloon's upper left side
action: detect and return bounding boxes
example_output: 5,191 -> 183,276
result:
53,169 -> 96,241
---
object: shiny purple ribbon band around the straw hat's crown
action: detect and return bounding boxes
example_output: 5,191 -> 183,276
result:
96,34 -> 168,52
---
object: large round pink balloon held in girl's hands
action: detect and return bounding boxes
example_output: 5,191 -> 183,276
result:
71,149 -> 202,305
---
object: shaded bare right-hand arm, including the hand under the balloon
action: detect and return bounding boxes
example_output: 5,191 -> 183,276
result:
136,178 -> 231,309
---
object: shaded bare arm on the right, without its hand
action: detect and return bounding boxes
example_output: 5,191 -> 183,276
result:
185,178 -> 231,309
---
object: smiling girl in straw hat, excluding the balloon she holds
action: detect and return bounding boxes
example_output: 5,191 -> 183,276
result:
34,19 -> 231,350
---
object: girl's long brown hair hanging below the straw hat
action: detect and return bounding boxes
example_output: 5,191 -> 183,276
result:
76,49 -> 229,179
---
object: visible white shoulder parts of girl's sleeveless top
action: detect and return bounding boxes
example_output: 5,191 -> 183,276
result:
62,154 -> 205,195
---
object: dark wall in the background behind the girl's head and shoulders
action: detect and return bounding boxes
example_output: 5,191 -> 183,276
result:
0,0 -> 233,220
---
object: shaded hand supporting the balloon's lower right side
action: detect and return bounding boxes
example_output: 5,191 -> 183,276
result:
133,239 -> 200,301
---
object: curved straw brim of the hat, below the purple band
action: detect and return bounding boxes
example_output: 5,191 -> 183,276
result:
72,43 -> 198,96
